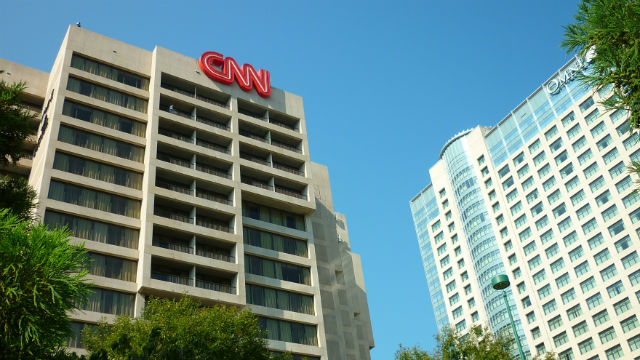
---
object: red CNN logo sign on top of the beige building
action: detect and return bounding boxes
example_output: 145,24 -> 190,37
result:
198,51 -> 271,98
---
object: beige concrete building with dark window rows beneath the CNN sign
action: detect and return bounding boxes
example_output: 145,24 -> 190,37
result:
0,27 -> 373,360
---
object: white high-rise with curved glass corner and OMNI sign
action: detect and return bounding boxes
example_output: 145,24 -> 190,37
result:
410,54 -> 640,360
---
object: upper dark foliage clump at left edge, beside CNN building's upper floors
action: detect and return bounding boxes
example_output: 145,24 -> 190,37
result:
0,81 -> 35,165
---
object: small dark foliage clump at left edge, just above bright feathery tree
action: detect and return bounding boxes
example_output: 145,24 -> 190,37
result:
0,176 -> 36,220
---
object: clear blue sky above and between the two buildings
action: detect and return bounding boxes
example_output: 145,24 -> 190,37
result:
0,0 -> 578,360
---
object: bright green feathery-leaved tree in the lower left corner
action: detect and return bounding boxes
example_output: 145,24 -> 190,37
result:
0,210 -> 90,359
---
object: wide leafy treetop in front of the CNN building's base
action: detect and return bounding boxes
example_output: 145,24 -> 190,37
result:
83,296 -> 290,360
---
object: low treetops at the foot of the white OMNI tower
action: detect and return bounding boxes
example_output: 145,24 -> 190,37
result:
395,325 -> 555,360
